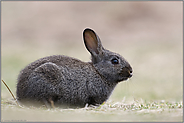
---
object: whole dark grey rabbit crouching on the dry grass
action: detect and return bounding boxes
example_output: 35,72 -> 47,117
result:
16,28 -> 132,107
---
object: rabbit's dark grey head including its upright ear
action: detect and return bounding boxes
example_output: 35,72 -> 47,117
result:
83,28 -> 132,82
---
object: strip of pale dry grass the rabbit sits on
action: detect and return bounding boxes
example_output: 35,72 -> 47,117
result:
1,100 -> 183,122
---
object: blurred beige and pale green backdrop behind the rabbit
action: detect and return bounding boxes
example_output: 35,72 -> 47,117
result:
1,1 -> 183,121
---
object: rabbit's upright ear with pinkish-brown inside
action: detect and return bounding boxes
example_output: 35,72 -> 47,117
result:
83,28 -> 103,56
